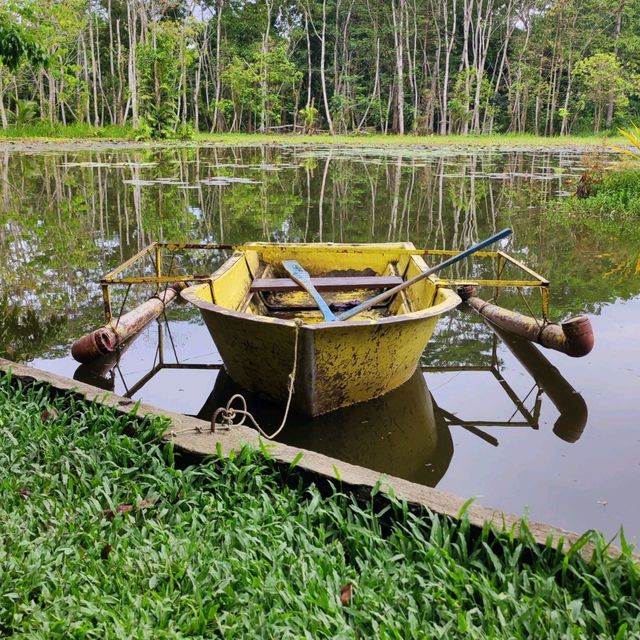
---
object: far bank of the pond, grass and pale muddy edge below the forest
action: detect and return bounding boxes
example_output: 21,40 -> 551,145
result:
0,125 -> 626,152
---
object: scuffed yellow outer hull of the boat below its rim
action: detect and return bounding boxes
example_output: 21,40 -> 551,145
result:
202,310 -> 444,416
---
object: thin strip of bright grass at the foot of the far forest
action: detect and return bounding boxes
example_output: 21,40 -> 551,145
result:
0,122 -> 626,148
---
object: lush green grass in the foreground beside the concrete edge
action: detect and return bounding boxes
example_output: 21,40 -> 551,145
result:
0,375 -> 640,639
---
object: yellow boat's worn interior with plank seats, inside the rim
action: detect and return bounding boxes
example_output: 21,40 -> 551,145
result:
188,243 -> 446,322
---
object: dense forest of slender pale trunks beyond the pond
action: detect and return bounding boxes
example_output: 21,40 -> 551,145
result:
0,0 -> 640,137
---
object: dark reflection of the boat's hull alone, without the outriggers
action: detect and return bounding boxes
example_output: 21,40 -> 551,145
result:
198,370 -> 453,487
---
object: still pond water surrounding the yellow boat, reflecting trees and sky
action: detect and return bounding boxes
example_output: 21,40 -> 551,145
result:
0,145 -> 640,538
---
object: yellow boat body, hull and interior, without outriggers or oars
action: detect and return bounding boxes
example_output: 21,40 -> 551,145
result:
181,242 -> 460,416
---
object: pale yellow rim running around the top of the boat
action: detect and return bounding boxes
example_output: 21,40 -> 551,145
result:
180,242 -> 462,331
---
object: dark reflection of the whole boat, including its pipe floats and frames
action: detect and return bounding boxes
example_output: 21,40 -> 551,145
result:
74,322 -> 587,487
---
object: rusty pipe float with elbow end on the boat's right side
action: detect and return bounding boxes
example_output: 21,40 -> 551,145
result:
458,285 -> 594,358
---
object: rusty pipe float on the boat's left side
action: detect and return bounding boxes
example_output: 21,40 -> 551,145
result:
71,282 -> 187,363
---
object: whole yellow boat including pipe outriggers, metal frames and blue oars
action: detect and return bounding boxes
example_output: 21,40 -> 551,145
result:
72,230 -> 593,416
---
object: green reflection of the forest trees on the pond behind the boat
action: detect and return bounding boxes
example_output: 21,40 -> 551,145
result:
0,145 -> 640,364
